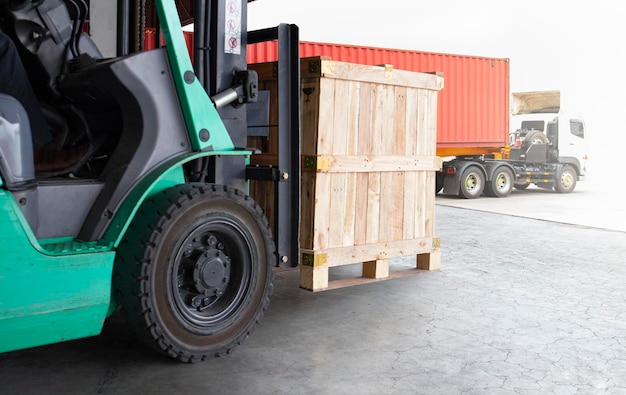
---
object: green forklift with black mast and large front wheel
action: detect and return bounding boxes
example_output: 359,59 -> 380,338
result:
0,0 -> 300,362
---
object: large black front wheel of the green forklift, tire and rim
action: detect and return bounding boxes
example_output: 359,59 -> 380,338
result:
114,184 -> 275,362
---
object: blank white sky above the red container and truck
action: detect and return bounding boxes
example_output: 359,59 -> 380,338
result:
248,0 -> 626,176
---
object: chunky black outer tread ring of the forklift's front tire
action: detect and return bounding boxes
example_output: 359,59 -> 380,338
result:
113,184 -> 275,362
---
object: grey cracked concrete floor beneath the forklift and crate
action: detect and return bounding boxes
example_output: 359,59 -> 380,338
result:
0,186 -> 626,394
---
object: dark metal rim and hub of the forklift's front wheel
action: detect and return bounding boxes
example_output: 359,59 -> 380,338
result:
169,215 -> 255,335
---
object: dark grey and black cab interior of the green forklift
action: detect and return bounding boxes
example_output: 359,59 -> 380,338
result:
0,0 -> 191,241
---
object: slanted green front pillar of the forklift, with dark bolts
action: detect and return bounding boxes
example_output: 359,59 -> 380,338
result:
155,0 -> 234,151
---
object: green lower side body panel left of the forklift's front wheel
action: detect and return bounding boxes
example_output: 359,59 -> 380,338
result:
0,190 -> 115,352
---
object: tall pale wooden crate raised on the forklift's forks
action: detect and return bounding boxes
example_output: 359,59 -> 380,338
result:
248,58 -> 443,291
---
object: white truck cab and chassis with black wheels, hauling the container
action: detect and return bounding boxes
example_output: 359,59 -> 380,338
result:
440,91 -> 587,199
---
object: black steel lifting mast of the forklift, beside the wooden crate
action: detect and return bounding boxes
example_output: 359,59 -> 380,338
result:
117,0 -> 300,267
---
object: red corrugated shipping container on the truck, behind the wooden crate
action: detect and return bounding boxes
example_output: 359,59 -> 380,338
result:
247,41 -> 509,156
